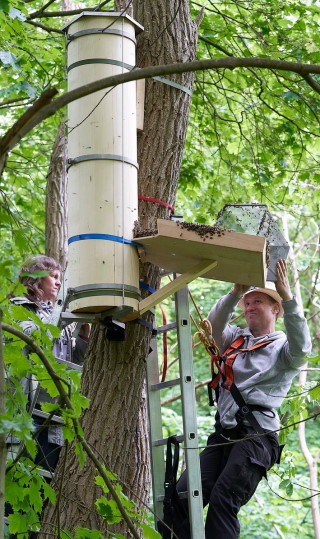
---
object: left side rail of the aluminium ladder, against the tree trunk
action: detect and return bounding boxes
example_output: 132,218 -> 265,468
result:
147,336 -> 165,526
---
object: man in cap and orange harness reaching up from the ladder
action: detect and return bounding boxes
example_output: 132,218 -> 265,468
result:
174,260 -> 311,539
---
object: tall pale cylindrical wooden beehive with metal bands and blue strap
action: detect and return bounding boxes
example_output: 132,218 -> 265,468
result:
67,12 -> 140,312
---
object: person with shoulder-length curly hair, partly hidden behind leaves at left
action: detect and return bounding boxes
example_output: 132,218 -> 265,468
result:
11,255 -> 90,472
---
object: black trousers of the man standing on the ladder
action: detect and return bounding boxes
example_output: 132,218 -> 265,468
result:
173,425 -> 280,539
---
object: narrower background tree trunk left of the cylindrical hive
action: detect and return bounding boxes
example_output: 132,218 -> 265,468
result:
46,123 -> 68,269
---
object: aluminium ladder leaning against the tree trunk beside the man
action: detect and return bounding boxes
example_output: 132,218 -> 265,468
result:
147,287 -> 205,539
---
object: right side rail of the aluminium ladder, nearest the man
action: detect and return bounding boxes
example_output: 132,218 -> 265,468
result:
175,287 -> 205,539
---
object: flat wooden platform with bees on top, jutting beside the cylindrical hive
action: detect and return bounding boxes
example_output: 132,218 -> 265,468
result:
135,219 -> 267,287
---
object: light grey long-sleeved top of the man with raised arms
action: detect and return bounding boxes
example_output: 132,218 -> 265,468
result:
208,292 -> 311,430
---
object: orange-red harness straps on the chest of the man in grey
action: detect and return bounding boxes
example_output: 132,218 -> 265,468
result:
208,335 -> 272,391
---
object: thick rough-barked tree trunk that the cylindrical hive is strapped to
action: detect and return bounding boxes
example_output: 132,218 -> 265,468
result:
44,0 -> 197,537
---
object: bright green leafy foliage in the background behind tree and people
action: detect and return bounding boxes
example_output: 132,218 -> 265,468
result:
0,0 -> 320,539
